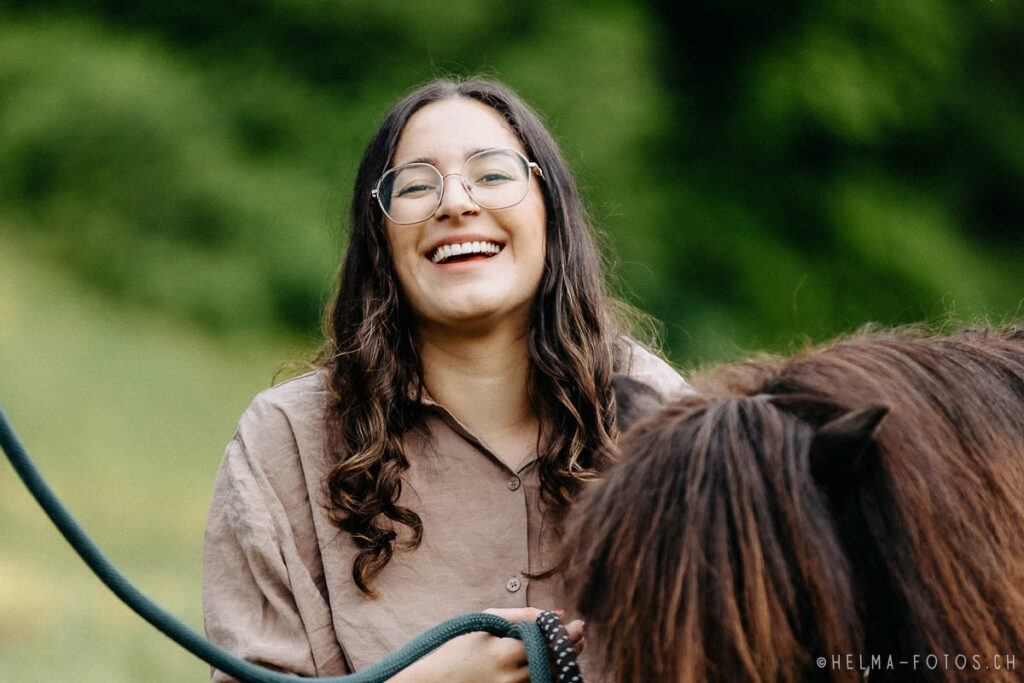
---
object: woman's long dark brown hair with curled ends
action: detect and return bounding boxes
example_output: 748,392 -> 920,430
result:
321,79 -> 629,597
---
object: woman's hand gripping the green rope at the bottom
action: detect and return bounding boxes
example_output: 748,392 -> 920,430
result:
391,607 -> 584,683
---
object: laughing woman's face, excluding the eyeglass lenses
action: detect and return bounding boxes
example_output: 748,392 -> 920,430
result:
384,98 -> 547,332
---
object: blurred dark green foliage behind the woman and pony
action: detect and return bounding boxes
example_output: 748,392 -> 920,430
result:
0,0 -> 1024,364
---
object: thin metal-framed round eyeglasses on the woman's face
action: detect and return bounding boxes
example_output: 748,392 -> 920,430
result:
370,150 -> 544,225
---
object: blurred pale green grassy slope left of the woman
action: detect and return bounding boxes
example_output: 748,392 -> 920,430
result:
0,237 -> 304,683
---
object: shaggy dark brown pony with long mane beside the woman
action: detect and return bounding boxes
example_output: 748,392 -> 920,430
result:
562,328 -> 1024,683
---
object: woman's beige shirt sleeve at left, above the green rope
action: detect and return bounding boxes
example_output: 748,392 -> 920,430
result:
203,435 -> 348,682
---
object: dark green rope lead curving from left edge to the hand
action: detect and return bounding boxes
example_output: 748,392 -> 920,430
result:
0,409 -> 551,683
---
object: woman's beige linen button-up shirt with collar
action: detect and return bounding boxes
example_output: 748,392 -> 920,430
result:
203,346 -> 690,681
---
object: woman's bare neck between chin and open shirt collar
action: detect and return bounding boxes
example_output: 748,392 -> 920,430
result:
419,321 -> 539,469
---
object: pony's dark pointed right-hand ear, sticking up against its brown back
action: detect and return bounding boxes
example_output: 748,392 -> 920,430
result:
811,405 -> 889,484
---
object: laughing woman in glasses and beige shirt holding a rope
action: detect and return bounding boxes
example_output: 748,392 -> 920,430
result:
204,80 -> 688,681
